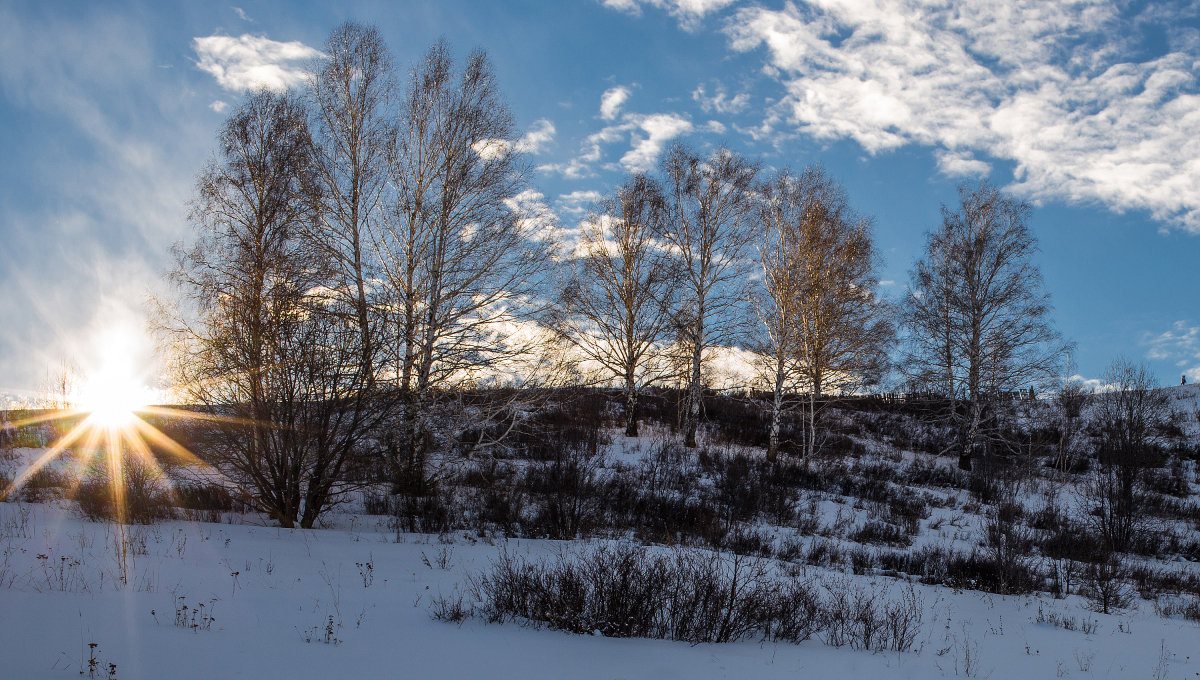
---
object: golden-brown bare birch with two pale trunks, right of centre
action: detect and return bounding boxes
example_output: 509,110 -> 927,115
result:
760,168 -> 894,459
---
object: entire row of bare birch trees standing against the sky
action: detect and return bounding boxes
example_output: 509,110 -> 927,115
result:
158,23 -> 1094,526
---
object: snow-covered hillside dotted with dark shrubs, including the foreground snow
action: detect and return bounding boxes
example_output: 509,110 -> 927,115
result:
0,386 -> 1200,679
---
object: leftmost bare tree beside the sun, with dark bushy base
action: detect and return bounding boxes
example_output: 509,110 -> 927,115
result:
162,91 -> 372,526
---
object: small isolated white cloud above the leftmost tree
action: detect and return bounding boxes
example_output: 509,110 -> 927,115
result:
192,34 -> 323,91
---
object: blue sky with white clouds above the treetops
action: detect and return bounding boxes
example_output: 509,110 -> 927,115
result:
0,0 -> 1200,393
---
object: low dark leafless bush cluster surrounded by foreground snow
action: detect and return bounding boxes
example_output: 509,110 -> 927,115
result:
473,544 -> 924,651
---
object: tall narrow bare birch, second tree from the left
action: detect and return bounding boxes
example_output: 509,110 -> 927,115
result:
308,23 -> 392,381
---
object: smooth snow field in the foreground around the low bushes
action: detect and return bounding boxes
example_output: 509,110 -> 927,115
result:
0,494 -> 1200,679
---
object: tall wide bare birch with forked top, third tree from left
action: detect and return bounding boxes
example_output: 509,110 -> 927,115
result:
374,42 -> 550,491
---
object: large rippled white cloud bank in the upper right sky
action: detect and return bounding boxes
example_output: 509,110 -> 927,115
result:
726,0 -> 1200,233
